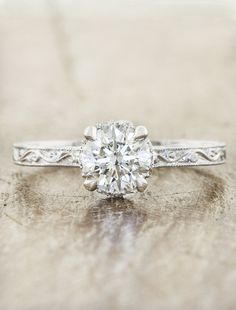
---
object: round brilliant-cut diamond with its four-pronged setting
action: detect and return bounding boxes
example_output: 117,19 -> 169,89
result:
81,121 -> 153,196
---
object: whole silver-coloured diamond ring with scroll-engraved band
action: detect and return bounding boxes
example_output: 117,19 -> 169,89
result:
13,121 -> 226,197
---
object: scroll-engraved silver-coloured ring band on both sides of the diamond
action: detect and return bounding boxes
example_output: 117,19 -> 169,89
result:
13,140 -> 226,168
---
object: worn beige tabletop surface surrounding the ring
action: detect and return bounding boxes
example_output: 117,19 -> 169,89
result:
0,1 -> 236,310
